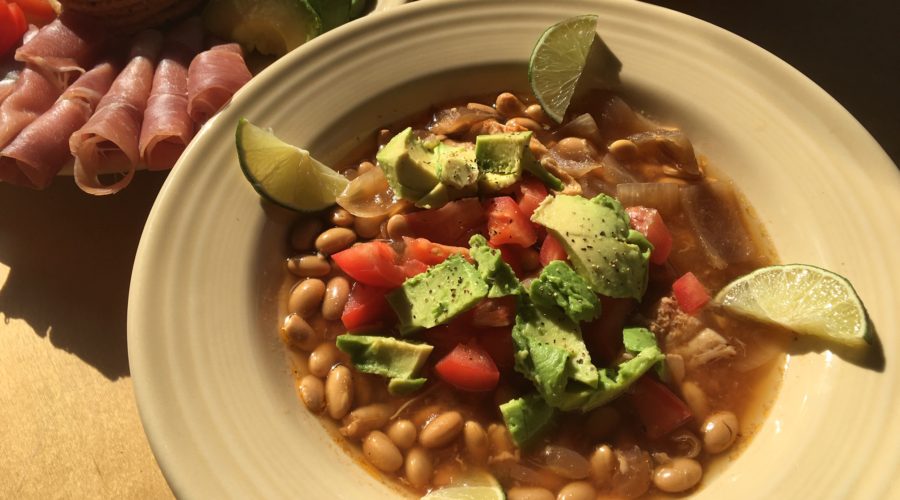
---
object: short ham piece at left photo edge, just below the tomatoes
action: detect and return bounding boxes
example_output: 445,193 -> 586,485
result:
0,66 -> 62,148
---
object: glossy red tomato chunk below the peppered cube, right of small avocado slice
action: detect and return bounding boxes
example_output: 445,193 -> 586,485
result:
434,344 -> 500,392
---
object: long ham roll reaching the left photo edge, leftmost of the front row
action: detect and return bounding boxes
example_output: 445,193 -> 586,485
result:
0,62 -> 118,189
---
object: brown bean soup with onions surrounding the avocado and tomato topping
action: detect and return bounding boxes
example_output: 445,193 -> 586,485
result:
280,92 -> 789,499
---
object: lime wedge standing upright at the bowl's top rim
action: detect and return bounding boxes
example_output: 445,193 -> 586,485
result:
528,15 -> 622,122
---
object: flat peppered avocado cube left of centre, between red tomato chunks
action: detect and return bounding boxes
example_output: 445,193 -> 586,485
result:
387,255 -> 488,335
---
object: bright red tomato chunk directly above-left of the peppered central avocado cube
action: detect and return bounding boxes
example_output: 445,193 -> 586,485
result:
331,241 -> 407,288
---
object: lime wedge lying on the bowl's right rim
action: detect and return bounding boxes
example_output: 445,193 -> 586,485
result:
714,264 -> 872,346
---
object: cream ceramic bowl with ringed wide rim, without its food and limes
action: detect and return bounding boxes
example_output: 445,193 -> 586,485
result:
128,0 -> 900,499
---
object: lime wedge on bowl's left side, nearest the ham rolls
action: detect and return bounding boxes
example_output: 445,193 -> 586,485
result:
235,118 -> 349,212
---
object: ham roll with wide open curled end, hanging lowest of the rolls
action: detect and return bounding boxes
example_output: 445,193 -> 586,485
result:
69,30 -> 163,195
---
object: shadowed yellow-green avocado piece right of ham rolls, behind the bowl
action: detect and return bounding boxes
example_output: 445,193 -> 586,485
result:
203,0 -> 322,56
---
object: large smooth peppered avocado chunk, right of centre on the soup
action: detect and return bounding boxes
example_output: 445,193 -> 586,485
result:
531,194 -> 653,300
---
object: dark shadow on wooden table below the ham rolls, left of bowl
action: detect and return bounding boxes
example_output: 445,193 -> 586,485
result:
0,172 -> 166,380
